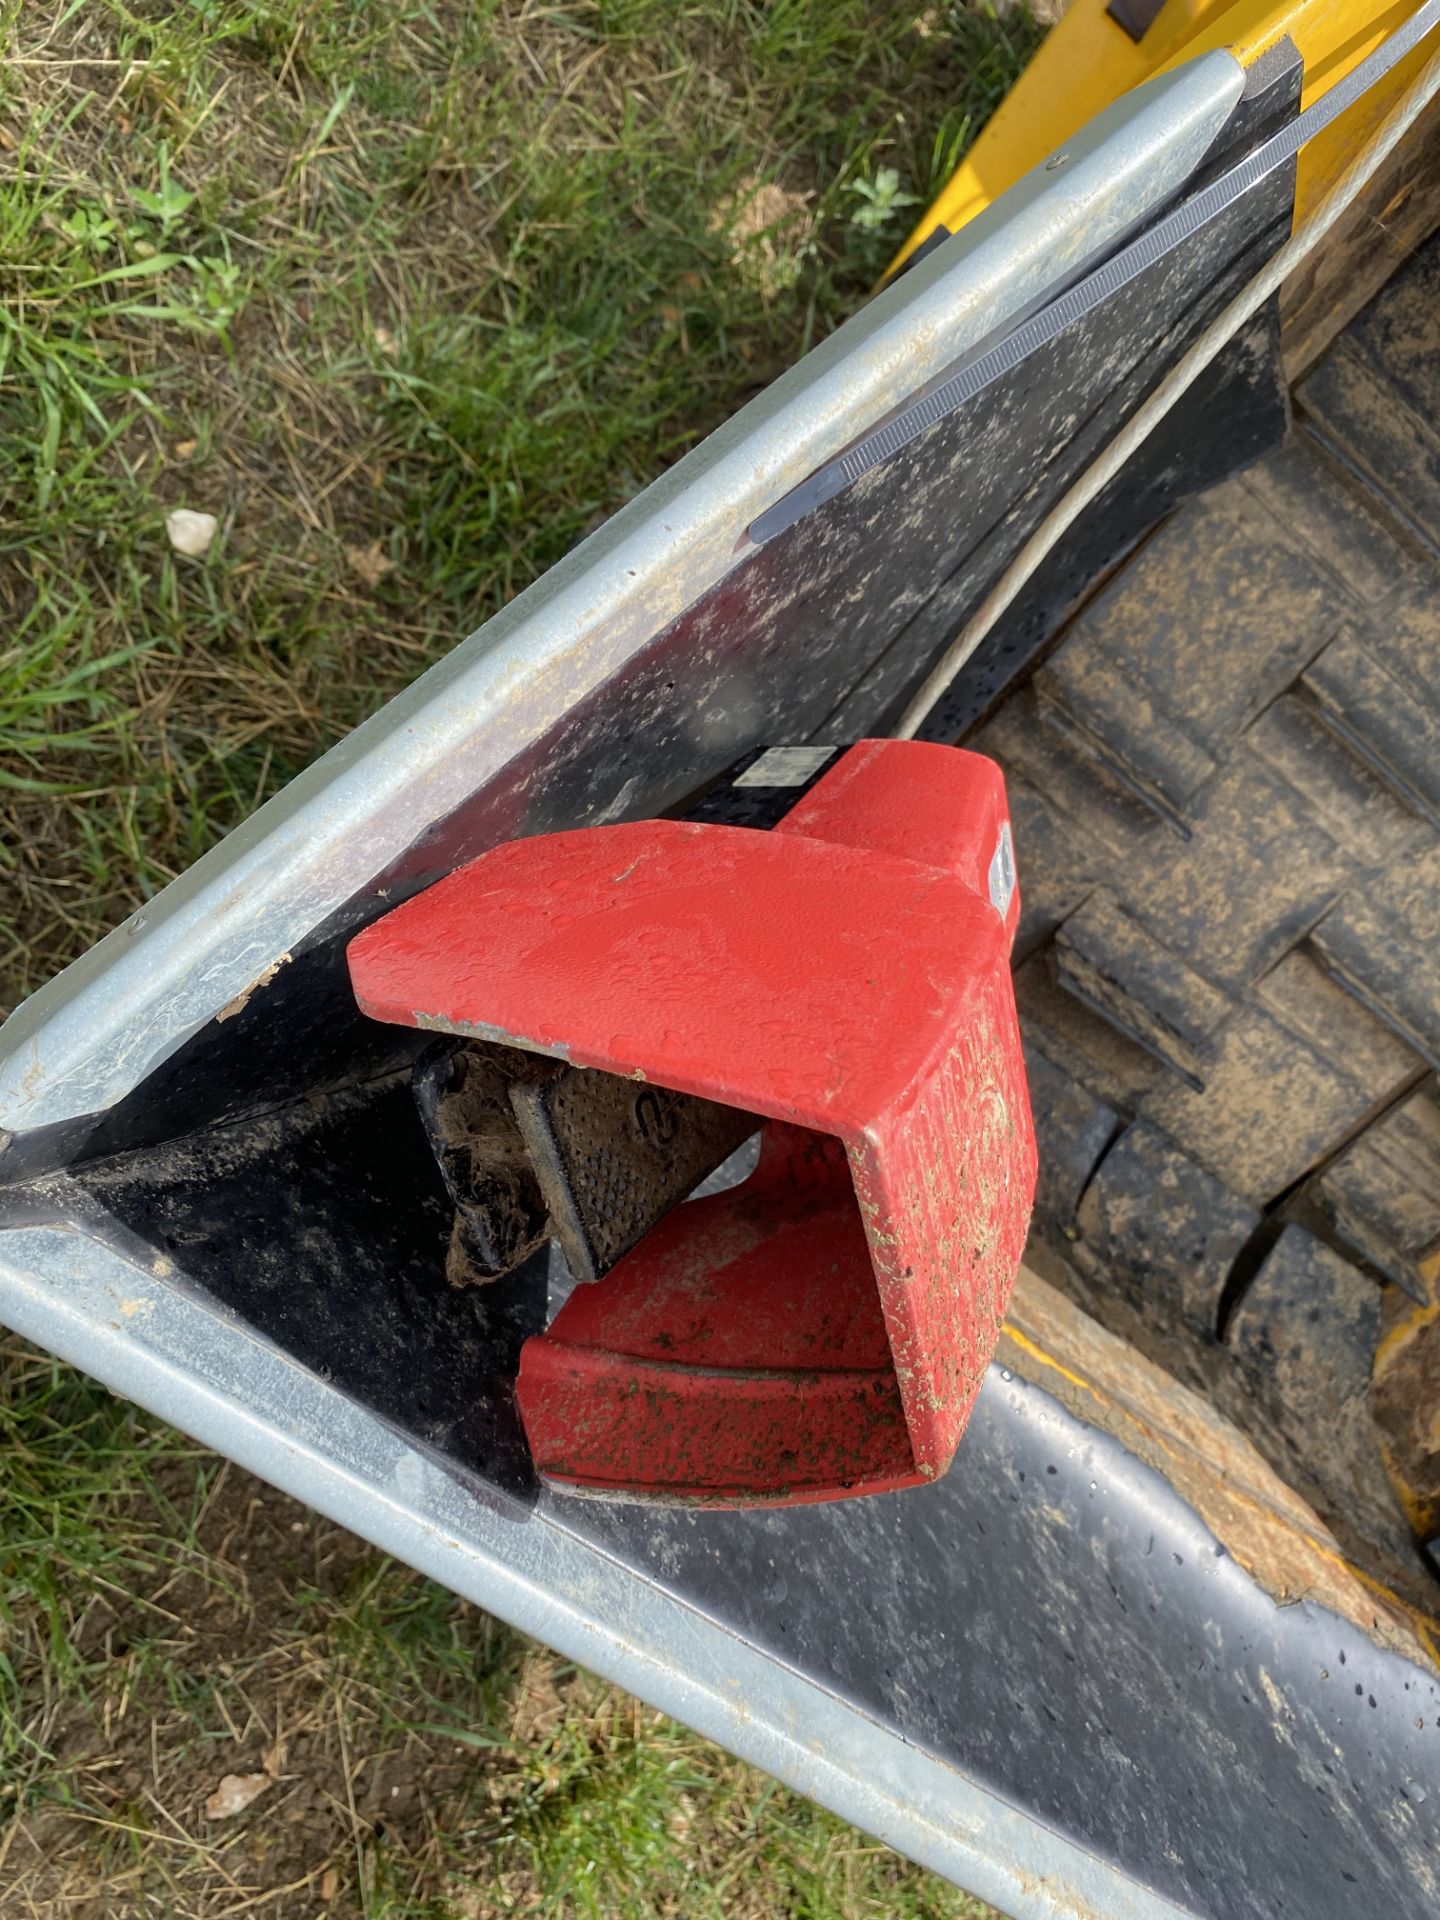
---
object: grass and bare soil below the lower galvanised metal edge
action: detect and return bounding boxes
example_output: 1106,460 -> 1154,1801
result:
0,1342 -> 987,1920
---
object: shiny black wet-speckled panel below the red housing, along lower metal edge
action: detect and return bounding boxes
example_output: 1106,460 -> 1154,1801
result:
545,1367 -> 1440,1920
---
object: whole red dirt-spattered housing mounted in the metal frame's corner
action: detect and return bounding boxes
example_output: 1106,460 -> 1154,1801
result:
349,741 -> 1035,1505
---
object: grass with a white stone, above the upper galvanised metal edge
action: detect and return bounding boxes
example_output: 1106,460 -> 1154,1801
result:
0,0 -> 1035,1006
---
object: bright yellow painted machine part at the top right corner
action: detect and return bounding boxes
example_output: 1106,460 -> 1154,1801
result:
891,0 -> 1434,273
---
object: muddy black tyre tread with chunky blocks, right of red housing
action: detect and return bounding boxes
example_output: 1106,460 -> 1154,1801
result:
966,238 -> 1440,1584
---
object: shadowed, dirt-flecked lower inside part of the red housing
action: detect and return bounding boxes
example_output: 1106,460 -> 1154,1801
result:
518,1121 -> 920,1505
